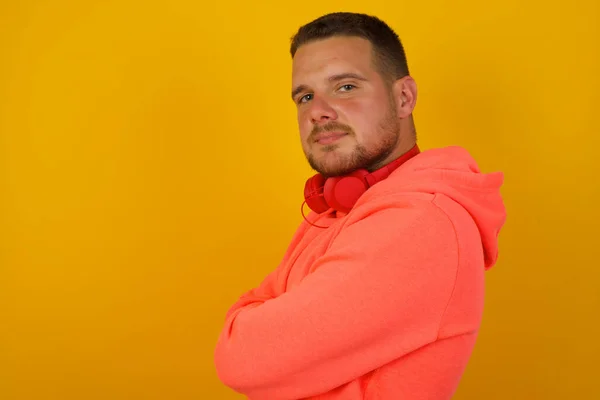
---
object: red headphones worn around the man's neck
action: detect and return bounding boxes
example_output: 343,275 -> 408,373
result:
304,145 -> 420,214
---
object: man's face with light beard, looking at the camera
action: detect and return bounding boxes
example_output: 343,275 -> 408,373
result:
292,37 -> 400,176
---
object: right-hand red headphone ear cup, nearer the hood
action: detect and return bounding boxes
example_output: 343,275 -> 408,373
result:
323,169 -> 369,213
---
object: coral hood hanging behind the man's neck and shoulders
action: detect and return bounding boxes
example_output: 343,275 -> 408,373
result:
366,146 -> 506,270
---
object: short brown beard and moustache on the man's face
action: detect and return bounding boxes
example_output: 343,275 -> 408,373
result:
305,99 -> 400,178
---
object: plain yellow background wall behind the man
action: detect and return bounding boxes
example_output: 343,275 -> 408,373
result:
0,0 -> 600,400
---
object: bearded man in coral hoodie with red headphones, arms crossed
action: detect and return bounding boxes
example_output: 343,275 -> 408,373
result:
215,13 -> 505,400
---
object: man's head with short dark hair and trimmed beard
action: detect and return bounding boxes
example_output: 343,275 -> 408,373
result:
290,13 -> 417,176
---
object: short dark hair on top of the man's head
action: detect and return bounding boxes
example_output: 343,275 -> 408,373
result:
290,12 -> 409,81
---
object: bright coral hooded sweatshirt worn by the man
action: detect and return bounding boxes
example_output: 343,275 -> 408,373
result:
215,146 -> 506,400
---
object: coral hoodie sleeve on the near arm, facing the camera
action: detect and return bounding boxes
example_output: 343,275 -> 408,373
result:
215,203 -> 458,400
